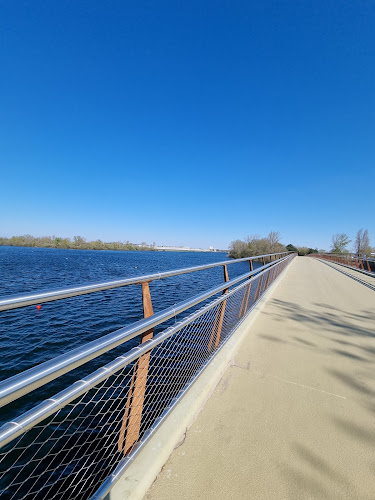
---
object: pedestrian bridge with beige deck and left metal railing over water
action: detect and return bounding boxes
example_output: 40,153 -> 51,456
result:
0,254 -> 375,500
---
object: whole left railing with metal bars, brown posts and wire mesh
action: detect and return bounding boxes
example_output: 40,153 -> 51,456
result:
0,253 -> 295,500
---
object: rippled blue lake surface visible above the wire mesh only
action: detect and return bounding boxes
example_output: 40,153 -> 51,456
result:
0,247 -> 258,420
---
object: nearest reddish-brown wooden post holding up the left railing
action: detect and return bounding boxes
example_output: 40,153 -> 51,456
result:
118,282 -> 154,455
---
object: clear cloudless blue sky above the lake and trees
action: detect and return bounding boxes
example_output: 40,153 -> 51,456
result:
0,0 -> 375,248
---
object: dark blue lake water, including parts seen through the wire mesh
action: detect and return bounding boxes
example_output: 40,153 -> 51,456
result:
0,247 -> 264,500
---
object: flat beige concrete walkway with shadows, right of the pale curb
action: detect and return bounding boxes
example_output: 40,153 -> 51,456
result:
146,257 -> 375,500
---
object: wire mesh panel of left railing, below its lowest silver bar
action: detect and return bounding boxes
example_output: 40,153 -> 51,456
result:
0,257 -> 293,500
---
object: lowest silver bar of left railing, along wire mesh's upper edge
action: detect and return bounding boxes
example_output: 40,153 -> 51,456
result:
0,258 -> 294,448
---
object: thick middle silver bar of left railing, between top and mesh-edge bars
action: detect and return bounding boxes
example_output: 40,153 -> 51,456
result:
0,257 -> 287,407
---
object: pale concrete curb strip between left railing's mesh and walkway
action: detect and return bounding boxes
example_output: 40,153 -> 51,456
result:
105,262 -> 293,500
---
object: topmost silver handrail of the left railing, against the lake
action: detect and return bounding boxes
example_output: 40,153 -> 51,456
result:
0,252 -> 291,311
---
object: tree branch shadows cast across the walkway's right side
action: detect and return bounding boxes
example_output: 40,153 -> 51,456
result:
259,297 -> 375,499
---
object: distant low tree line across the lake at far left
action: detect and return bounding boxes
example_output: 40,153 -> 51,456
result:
0,234 -> 155,250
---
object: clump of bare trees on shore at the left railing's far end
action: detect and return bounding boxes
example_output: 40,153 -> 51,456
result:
228,231 -> 318,259
